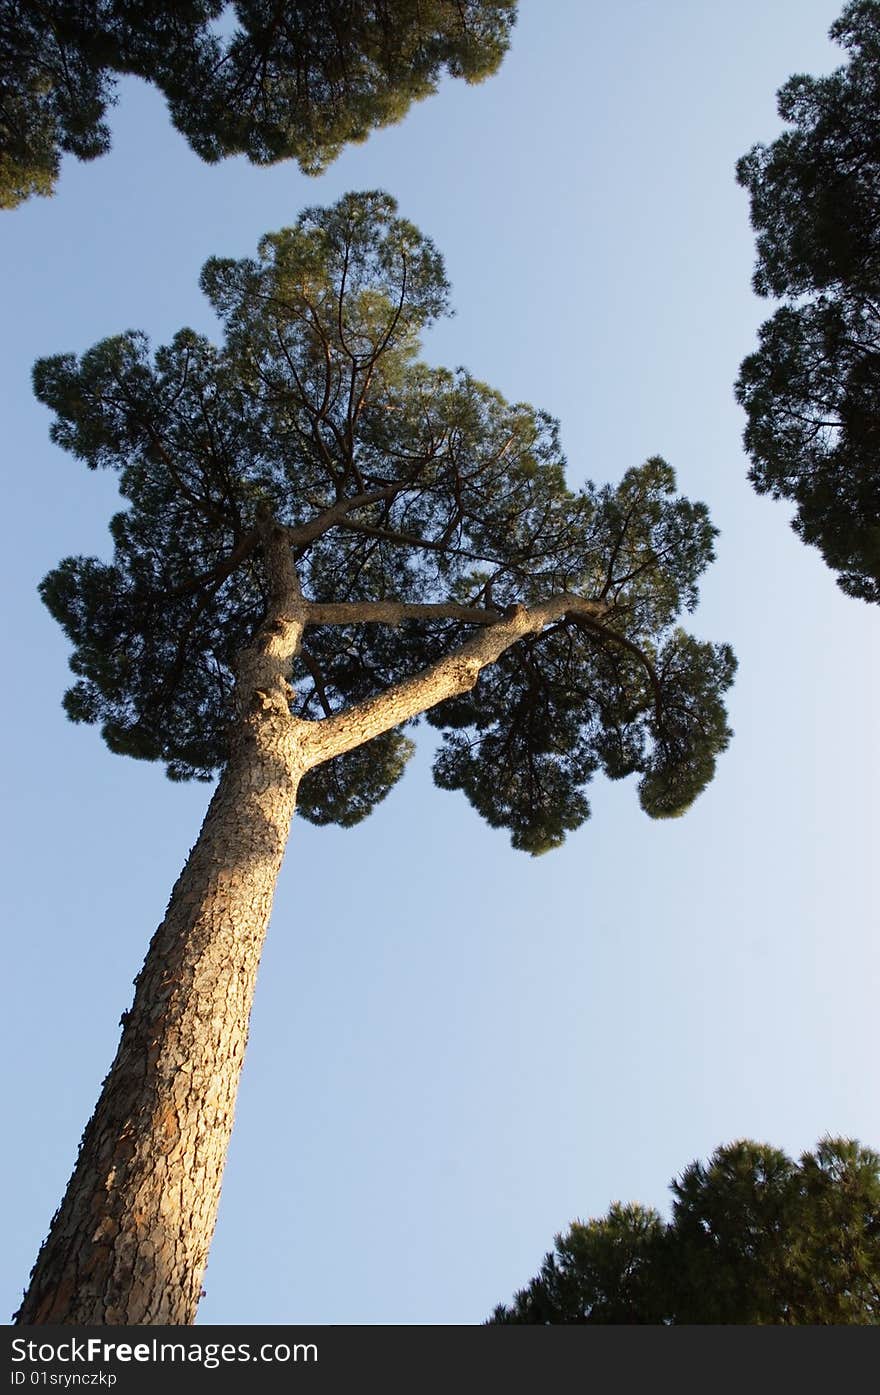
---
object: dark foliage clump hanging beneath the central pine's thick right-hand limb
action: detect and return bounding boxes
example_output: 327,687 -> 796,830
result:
428,622 -> 736,854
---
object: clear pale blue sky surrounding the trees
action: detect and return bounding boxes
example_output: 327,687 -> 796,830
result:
0,0 -> 880,1324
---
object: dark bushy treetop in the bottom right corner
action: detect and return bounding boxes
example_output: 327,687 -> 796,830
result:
490,1138 -> 880,1325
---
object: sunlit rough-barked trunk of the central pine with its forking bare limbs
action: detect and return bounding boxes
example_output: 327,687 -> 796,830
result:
15,519 -> 605,1325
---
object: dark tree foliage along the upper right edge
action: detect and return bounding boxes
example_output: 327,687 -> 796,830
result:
736,0 -> 880,601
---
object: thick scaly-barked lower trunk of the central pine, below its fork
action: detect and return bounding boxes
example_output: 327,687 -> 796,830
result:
15,714 -> 298,1325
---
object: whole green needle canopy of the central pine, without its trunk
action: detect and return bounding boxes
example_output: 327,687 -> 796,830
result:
35,193 -> 735,852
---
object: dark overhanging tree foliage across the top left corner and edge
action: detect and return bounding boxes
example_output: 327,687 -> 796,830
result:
0,0 -> 516,208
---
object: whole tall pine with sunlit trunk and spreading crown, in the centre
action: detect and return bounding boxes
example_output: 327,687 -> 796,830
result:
20,193 -> 735,1322
